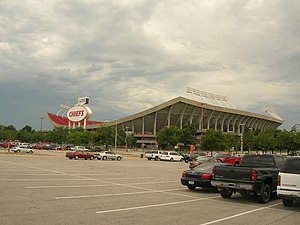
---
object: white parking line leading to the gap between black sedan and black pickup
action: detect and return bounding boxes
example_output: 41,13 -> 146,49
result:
96,196 -> 219,214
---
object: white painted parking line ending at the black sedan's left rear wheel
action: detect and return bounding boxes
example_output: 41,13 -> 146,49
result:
55,188 -> 185,199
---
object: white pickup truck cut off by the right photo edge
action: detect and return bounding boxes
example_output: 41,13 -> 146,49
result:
277,157 -> 300,206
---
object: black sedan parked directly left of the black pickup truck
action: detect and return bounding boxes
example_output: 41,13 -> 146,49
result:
181,161 -> 231,191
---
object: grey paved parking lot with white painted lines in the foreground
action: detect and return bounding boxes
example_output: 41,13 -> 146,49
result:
0,153 -> 300,225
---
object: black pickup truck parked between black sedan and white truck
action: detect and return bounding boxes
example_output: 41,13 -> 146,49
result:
211,154 -> 284,203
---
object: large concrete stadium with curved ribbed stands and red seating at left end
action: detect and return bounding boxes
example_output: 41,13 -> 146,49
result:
48,89 -> 284,149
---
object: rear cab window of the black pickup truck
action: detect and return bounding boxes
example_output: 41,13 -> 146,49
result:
241,155 -> 275,167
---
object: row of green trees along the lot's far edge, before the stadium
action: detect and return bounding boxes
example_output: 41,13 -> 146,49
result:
0,125 -> 300,154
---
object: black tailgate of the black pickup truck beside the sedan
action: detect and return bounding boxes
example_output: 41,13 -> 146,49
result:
214,166 -> 252,181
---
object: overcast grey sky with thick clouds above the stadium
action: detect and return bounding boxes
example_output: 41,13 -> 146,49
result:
0,0 -> 300,130
